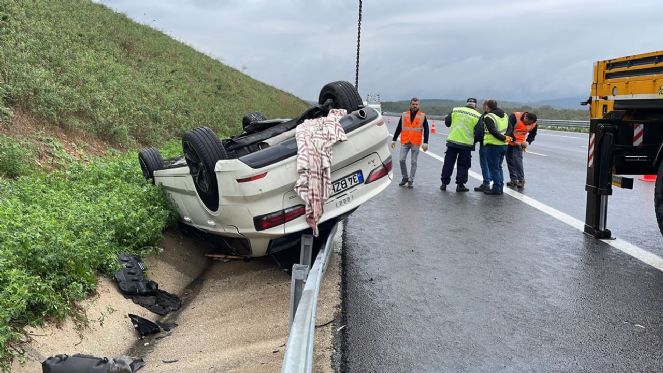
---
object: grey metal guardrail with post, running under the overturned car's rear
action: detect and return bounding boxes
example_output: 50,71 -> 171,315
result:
281,223 -> 338,373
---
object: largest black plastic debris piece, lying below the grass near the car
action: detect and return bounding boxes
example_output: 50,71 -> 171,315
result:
115,254 -> 182,316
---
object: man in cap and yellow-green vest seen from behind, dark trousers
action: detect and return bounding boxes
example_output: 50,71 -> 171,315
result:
440,98 -> 481,192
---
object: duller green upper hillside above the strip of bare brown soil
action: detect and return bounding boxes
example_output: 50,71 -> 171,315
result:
0,0 -> 307,145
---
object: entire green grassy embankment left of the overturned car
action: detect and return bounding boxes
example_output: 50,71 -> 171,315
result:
0,0 -> 306,370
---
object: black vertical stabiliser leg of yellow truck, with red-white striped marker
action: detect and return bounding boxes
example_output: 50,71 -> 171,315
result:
585,122 -> 617,238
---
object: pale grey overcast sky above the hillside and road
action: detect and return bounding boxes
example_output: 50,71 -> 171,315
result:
99,0 -> 663,102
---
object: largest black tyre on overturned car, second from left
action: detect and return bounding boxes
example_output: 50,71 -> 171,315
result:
182,127 -> 228,211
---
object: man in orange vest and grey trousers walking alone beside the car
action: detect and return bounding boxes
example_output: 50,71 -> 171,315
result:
391,97 -> 428,189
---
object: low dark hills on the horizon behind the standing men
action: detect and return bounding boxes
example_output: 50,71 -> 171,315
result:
382,98 -> 589,120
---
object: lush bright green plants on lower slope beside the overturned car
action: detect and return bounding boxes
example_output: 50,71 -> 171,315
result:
0,152 -> 176,370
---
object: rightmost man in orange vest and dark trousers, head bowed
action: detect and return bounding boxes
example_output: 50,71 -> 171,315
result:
506,111 -> 536,189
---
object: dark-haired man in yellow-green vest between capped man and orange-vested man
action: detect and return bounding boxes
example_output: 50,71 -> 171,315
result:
482,100 -> 513,195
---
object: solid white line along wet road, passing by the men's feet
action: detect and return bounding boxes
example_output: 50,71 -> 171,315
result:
424,147 -> 663,271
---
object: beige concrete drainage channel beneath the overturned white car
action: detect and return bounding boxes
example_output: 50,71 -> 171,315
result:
11,227 -> 341,373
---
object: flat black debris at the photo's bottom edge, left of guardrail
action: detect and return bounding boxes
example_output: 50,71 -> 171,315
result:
41,354 -> 145,373
